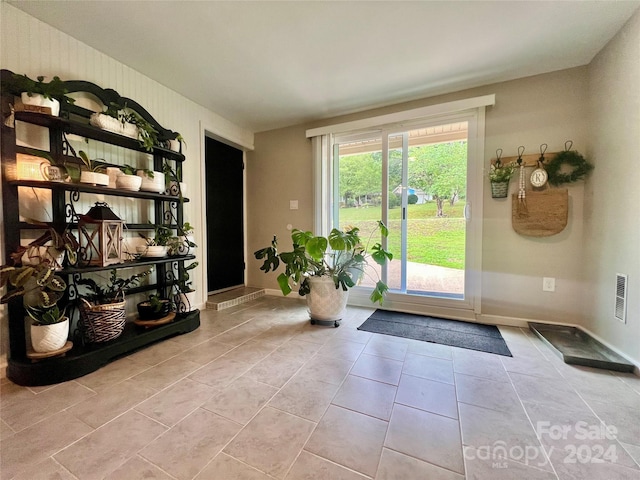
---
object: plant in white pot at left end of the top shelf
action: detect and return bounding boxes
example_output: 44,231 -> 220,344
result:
2,73 -> 75,117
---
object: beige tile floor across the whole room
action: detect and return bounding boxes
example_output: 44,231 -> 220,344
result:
0,297 -> 640,480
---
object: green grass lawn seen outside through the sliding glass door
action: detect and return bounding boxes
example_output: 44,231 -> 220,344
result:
340,202 -> 465,269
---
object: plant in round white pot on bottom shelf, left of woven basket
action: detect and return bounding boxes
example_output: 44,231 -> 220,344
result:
0,262 -> 69,353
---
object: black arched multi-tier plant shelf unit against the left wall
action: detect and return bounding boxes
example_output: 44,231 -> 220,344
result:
0,74 -> 200,386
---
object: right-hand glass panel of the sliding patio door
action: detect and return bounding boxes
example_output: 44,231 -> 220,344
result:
388,122 -> 467,299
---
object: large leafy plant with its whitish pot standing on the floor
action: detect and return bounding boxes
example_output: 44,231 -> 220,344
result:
254,222 -> 393,326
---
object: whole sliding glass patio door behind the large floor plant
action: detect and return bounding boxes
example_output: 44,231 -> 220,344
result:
333,116 -> 477,314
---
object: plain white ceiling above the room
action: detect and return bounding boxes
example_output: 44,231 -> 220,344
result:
9,0 -> 640,132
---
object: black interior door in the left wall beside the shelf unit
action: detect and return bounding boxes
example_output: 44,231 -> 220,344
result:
205,137 -> 244,292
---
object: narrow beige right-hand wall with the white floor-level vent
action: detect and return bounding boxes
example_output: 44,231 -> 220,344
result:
583,11 -> 640,363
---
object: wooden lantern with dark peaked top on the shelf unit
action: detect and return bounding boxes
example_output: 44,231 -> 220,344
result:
78,202 -> 124,267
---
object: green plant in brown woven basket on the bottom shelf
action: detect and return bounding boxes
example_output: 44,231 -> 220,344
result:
77,269 -> 151,343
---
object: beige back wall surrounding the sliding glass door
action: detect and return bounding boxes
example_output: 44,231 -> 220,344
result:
247,67 -> 588,323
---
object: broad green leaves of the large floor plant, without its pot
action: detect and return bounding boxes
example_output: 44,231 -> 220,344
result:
254,221 -> 393,304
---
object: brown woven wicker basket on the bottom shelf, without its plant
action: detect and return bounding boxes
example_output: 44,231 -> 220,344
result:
79,299 -> 126,343
